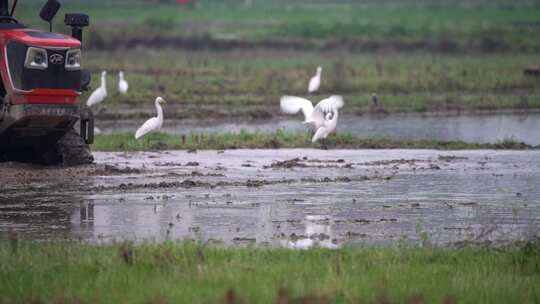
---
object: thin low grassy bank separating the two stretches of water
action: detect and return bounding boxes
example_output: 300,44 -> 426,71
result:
92,132 -> 540,151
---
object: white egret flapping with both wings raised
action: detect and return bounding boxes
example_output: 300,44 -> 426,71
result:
280,95 -> 344,132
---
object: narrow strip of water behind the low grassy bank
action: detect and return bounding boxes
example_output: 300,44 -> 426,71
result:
97,112 -> 540,145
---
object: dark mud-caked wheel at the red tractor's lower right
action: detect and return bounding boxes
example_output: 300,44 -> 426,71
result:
54,129 -> 94,166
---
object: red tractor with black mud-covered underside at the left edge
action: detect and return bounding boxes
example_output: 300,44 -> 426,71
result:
0,0 -> 94,165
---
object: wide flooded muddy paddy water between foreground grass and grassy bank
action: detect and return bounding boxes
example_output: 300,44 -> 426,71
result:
0,150 -> 540,248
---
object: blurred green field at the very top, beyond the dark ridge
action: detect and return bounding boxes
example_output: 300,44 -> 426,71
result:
17,0 -> 540,51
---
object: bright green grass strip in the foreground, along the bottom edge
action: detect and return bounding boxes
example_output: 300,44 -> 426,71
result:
0,239 -> 540,303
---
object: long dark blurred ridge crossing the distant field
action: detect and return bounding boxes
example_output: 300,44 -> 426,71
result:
88,33 -> 538,53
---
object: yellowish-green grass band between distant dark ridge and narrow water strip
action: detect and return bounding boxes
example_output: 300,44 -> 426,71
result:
81,49 -> 540,118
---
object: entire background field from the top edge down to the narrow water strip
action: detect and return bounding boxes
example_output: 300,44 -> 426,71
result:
13,0 -> 540,119
